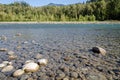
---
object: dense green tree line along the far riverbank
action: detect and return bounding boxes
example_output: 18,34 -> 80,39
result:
0,0 -> 120,21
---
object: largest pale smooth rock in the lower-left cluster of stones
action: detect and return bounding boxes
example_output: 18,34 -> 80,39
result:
23,62 -> 39,72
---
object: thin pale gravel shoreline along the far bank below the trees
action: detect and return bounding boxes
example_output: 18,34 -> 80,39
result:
0,21 -> 120,24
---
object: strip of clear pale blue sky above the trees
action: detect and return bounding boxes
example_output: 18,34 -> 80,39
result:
0,0 -> 86,6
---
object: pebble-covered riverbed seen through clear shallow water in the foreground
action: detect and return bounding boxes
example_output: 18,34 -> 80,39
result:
0,23 -> 120,80
